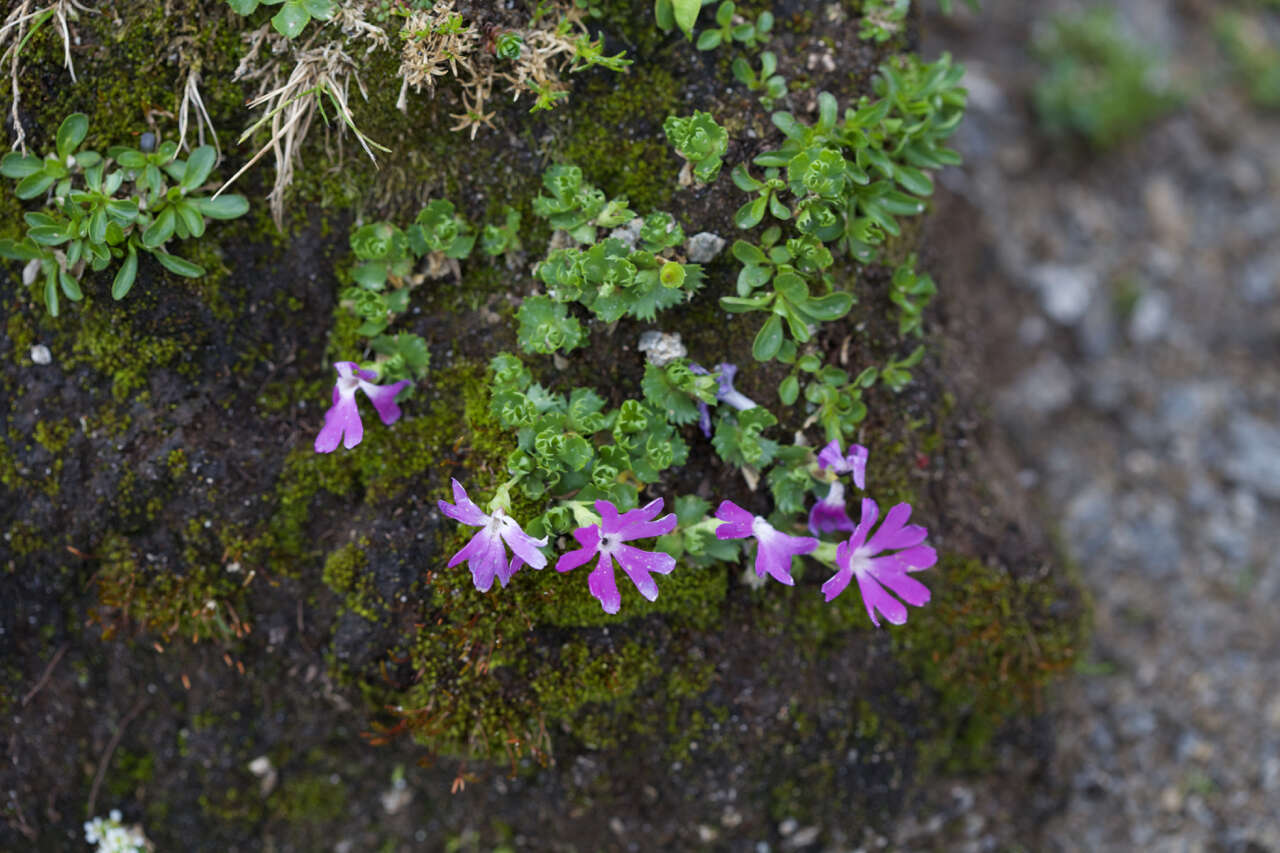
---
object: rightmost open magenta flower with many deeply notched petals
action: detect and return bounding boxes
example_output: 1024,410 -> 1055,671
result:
822,498 -> 938,628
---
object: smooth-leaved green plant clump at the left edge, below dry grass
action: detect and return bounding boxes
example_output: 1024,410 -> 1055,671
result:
0,113 -> 248,316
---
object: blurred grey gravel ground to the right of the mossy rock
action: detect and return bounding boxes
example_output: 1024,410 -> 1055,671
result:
899,0 -> 1280,853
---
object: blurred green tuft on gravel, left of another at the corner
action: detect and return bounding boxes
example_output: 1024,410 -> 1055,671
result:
1032,8 -> 1183,149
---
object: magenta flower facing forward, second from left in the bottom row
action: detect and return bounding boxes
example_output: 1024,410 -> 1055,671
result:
556,498 -> 676,613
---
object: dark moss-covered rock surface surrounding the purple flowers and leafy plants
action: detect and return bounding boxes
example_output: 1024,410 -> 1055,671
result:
0,0 -> 1082,850
